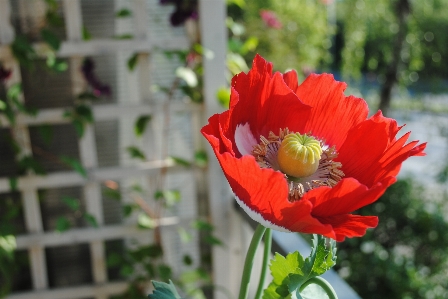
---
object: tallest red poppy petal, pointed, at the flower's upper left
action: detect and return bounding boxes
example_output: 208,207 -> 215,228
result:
223,55 -> 310,157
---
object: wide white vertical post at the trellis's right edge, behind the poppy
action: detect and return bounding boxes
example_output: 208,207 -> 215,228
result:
199,0 -> 236,299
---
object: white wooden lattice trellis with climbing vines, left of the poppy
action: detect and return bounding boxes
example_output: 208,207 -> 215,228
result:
0,0 -> 228,299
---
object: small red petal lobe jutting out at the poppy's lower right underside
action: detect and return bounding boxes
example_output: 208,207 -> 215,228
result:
321,214 -> 378,242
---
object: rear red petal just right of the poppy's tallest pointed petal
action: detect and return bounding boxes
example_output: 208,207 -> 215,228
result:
283,72 -> 369,149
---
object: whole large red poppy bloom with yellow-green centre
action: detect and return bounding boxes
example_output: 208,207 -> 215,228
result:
201,55 -> 426,241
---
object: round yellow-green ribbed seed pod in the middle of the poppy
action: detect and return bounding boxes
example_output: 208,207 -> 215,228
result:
277,133 -> 322,178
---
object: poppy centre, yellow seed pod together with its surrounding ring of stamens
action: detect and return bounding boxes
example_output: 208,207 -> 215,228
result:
252,128 -> 344,201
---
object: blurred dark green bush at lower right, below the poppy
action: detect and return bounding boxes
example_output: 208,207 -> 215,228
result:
336,179 -> 448,299
